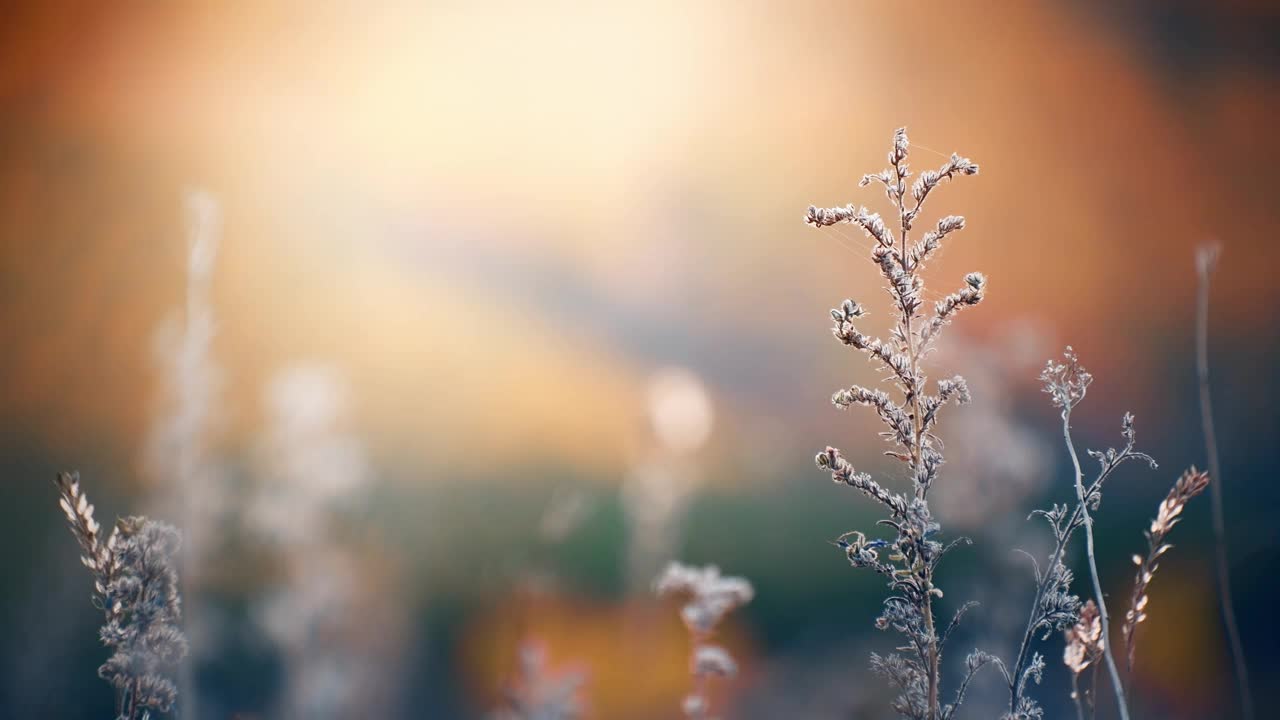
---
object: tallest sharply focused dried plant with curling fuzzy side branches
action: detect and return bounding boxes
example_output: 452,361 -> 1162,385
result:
805,128 -> 1007,720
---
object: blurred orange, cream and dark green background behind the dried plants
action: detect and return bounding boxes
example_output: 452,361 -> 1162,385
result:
0,0 -> 1280,720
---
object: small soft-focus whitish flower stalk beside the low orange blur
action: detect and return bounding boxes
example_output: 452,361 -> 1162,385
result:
654,562 -> 755,720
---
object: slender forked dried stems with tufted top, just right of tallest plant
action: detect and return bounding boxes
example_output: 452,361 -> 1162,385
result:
1007,346 -> 1156,720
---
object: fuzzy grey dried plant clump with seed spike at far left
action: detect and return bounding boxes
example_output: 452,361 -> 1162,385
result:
54,473 -> 187,720
